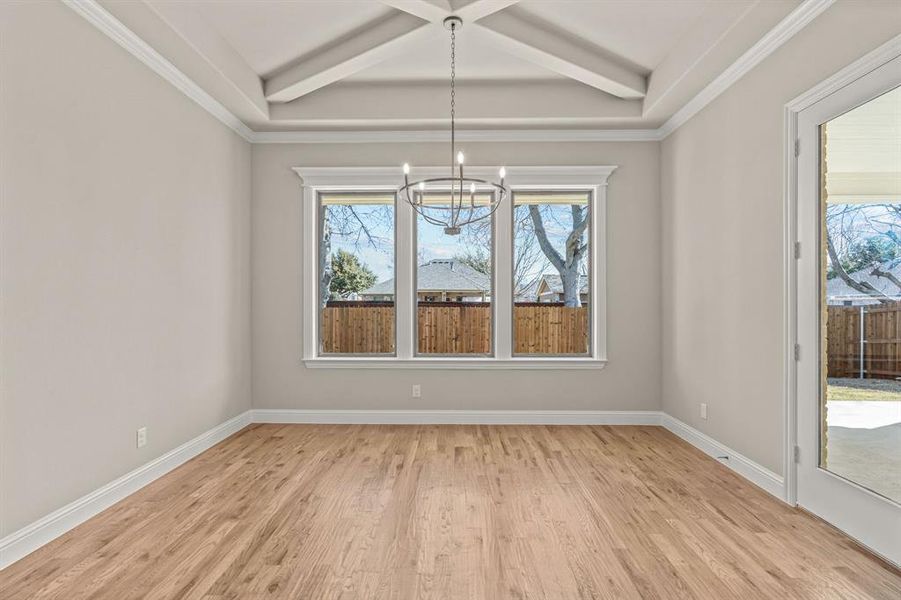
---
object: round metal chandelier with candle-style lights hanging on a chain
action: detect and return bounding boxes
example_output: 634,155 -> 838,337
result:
398,16 -> 509,235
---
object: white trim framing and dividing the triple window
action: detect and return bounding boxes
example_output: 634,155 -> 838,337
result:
294,166 -> 616,369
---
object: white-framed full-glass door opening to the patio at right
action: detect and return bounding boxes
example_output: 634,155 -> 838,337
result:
797,54 -> 901,563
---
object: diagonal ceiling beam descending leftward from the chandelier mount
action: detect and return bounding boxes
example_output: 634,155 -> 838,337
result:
265,12 -> 434,103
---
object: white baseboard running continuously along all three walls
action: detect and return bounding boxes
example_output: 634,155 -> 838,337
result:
0,409 -> 785,569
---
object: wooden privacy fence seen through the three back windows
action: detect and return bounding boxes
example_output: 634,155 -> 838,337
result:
320,301 -> 588,354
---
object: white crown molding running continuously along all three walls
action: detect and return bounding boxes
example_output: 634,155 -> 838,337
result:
62,0 -> 835,144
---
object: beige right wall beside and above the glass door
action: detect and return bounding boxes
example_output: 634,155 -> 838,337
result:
661,0 -> 901,473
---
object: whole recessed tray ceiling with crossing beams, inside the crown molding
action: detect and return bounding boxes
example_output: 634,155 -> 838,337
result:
93,0 -> 816,132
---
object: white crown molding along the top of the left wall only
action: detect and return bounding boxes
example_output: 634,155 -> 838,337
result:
62,0 -> 254,142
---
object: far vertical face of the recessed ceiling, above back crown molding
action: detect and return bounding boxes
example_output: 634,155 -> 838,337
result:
270,80 -> 641,129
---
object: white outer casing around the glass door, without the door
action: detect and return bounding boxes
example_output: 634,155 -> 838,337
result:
783,35 -> 901,564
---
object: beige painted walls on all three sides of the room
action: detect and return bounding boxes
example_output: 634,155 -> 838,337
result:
0,0 -> 899,536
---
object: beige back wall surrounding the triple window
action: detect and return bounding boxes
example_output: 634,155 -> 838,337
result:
252,143 -> 660,410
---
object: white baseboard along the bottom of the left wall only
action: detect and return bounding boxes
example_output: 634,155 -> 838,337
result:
0,410 -> 251,569
